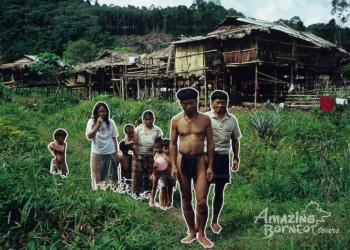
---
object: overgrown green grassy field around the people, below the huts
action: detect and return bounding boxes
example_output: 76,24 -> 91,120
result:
0,92 -> 350,249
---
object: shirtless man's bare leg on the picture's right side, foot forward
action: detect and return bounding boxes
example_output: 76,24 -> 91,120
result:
194,155 -> 214,247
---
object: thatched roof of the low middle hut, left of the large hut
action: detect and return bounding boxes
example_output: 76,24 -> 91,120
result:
75,50 -> 165,72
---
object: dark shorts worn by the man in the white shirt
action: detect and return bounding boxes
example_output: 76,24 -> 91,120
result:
209,154 -> 231,184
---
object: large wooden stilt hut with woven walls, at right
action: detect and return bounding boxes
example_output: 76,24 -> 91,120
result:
174,17 -> 349,107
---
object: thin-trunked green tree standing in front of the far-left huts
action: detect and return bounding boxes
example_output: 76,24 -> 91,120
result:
28,52 -> 74,96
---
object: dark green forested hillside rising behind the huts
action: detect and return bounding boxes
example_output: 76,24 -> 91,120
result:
0,0 -> 350,61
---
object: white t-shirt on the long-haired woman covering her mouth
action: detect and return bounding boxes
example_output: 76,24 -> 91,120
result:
86,119 -> 118,155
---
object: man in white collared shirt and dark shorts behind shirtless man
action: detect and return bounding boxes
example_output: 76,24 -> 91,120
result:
204,90 -> 242,234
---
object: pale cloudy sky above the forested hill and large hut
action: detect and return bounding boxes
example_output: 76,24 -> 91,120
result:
98,0 -> 349,26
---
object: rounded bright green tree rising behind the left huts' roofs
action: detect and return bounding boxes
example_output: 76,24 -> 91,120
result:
63,40 -> 98,64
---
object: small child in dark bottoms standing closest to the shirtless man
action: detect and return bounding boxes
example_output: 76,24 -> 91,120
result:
154,139 -> 176,209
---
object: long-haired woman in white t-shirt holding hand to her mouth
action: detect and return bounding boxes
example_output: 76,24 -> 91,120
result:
86,102 -> 119,191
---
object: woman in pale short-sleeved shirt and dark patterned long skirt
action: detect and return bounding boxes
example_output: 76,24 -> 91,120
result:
131,110 -> 163,197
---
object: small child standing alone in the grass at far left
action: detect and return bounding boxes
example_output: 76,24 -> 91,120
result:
48,129 -> 69,178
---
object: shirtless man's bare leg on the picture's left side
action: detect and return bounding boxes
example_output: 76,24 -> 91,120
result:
177,154 -> 196,243
